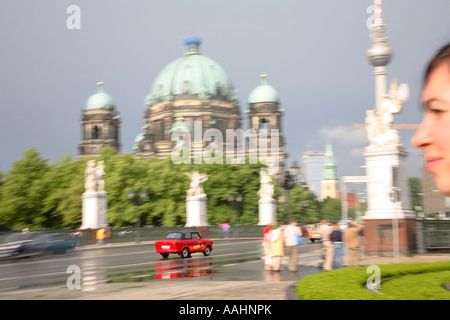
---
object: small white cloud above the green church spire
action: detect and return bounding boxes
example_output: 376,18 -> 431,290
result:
319,126 -> 369,146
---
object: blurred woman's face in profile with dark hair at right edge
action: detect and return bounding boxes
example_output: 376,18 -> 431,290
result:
411,43 -> 450,196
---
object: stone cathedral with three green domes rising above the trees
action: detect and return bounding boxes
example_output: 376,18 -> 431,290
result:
79,38 -> 287,175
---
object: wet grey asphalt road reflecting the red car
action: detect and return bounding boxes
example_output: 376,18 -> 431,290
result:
0,239 -> 320,298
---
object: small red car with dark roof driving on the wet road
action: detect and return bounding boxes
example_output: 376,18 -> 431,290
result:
155,231 -> 213,258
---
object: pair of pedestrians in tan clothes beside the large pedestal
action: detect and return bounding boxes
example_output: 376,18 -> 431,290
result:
320,220 -> 362,271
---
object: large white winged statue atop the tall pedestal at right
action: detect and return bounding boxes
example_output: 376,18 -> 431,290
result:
366,79 -> 409,146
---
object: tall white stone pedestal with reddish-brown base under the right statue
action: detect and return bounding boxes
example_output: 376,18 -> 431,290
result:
363,145 -> 416,255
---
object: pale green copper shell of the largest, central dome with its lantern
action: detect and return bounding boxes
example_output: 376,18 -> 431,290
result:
145,38 -> 238,106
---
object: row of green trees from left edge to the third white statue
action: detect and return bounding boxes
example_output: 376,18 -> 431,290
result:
0,147 -> 268,229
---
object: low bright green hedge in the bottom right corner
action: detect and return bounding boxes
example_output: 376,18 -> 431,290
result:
296,261 -> 450,300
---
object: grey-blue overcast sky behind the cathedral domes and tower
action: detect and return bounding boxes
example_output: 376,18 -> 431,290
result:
0,0 -> 450,176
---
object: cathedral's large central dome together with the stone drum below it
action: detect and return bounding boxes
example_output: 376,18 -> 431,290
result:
134,38 -> 242,157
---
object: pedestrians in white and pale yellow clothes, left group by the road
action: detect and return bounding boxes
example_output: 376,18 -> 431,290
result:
263,220 -> 302,272
